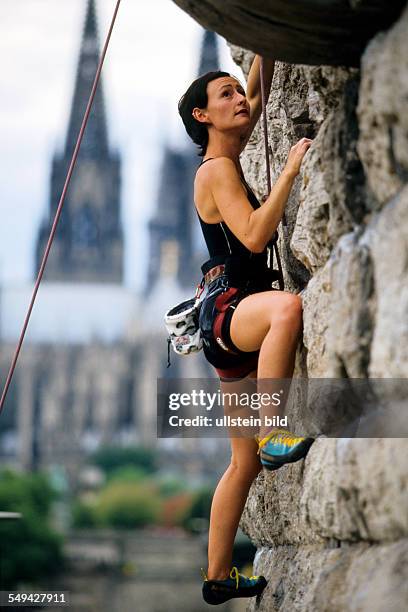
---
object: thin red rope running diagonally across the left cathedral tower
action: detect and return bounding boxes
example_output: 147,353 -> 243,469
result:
0,0 -> 121,413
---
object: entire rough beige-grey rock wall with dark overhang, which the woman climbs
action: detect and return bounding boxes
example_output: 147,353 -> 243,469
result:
178,0 -> 408,612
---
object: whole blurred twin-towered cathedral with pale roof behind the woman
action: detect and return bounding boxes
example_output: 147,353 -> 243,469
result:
0,5 -> 226,488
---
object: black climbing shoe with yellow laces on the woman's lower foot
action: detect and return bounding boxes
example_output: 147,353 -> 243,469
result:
203,566 -> 267,606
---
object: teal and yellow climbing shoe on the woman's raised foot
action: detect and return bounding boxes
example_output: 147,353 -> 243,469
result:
256,429 -> 314,470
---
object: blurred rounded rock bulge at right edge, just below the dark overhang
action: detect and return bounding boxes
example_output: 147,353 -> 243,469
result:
357,1 -> 408,209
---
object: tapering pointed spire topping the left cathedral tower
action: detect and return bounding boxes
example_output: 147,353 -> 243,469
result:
65,0 -> 108,158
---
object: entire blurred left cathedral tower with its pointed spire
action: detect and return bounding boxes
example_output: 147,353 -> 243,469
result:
35,0 -> 123,284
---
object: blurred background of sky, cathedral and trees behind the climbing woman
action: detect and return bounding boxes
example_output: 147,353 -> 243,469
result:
0,0 -> 253,612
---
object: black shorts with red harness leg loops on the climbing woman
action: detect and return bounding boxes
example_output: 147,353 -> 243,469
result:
199,275 -> 259,379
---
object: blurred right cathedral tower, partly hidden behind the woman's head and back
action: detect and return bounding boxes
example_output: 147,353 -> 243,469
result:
146,30 -> 220,295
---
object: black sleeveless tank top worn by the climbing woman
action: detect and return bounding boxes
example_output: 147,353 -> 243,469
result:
196,157 -> 261,258
